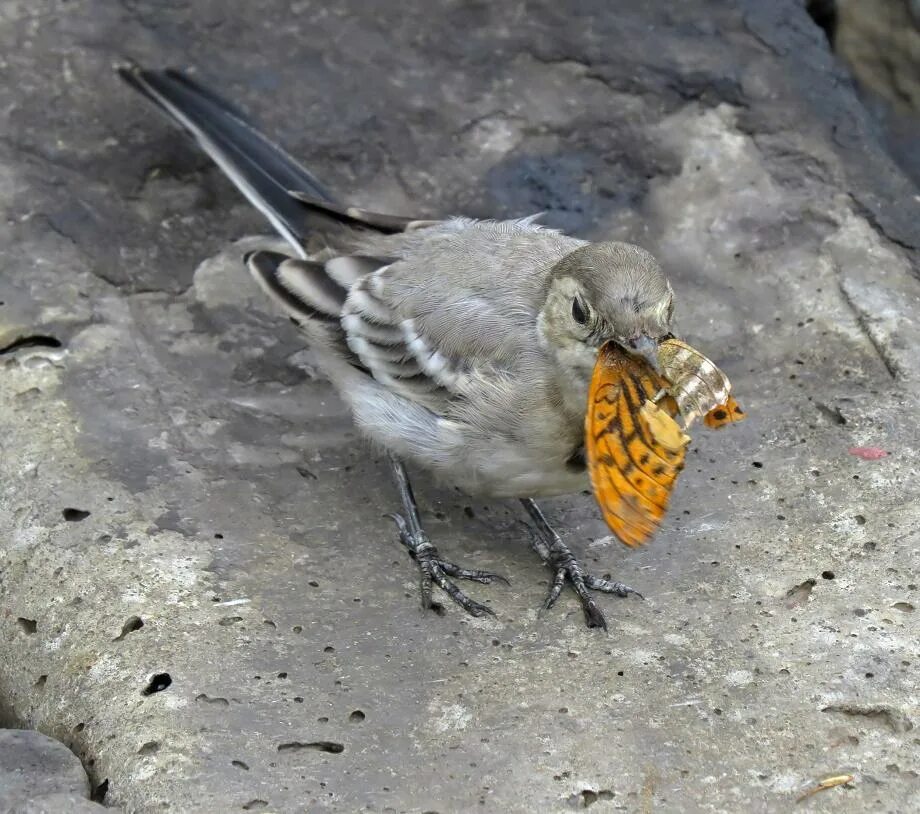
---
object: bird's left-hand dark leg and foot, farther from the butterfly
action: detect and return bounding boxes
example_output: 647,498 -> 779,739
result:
390,455 -> 508,616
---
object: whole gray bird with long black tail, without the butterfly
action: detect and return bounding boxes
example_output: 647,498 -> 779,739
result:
119,66 -> 673,628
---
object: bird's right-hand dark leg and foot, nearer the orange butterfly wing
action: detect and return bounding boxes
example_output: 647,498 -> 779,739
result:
521,498 -> 642,630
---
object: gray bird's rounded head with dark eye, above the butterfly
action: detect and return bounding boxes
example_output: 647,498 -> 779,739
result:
539,243 -> 674,381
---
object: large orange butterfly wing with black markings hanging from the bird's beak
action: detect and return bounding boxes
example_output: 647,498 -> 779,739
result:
585,342 -> 690,546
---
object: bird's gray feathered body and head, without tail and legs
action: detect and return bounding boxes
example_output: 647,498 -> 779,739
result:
249,218 -> 670,497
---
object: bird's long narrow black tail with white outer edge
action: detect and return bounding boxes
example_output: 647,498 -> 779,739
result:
118,66 -> 333,255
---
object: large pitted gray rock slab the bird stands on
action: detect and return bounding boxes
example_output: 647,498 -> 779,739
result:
0,0 -> 920,814
